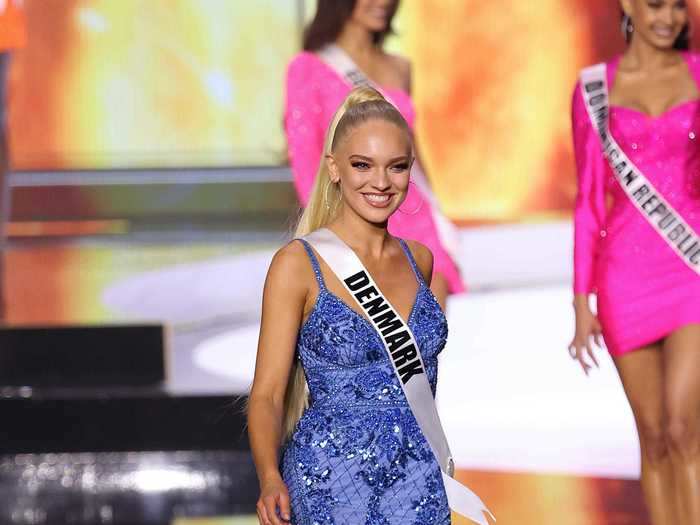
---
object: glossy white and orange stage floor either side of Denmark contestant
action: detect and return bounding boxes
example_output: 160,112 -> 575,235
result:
7,219 -> 646,525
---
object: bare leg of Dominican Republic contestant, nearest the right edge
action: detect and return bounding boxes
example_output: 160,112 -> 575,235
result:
664,324 -> 700,525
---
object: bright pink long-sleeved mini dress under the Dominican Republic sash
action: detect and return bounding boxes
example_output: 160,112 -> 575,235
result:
572,53 -> 700,356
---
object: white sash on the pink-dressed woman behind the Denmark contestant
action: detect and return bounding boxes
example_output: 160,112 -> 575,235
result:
317,44 -> 459,264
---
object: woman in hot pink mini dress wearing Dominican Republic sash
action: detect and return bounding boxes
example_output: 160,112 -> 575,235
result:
570,0 -> 700,525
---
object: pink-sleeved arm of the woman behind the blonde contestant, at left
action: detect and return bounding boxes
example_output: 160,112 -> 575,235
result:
284,53 -> 325,206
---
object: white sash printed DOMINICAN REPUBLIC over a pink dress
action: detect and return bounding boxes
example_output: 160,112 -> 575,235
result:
581,64 -> 700,274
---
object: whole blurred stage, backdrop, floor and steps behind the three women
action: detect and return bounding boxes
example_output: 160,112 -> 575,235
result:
0,0 -> 696,525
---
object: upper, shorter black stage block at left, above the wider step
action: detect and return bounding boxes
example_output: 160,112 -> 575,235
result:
0,324 -> 165,388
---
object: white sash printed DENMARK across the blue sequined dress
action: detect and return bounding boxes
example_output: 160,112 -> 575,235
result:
304,228 -> 493,525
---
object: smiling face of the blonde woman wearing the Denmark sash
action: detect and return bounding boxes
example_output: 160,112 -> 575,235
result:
326,118 -> 413,224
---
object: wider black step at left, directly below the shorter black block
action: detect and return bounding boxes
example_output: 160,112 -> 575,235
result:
0,389 -> 248,454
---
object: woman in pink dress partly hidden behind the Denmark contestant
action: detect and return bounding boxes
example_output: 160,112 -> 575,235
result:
284,0 -> 464,307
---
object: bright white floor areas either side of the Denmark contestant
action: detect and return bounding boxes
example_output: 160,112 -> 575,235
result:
103,222 -> 639,478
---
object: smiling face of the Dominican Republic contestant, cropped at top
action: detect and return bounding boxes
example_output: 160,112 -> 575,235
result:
622,0 -> 688,49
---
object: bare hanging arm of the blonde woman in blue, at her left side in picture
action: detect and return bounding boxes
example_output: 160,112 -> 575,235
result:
248,242 -> 309,525
